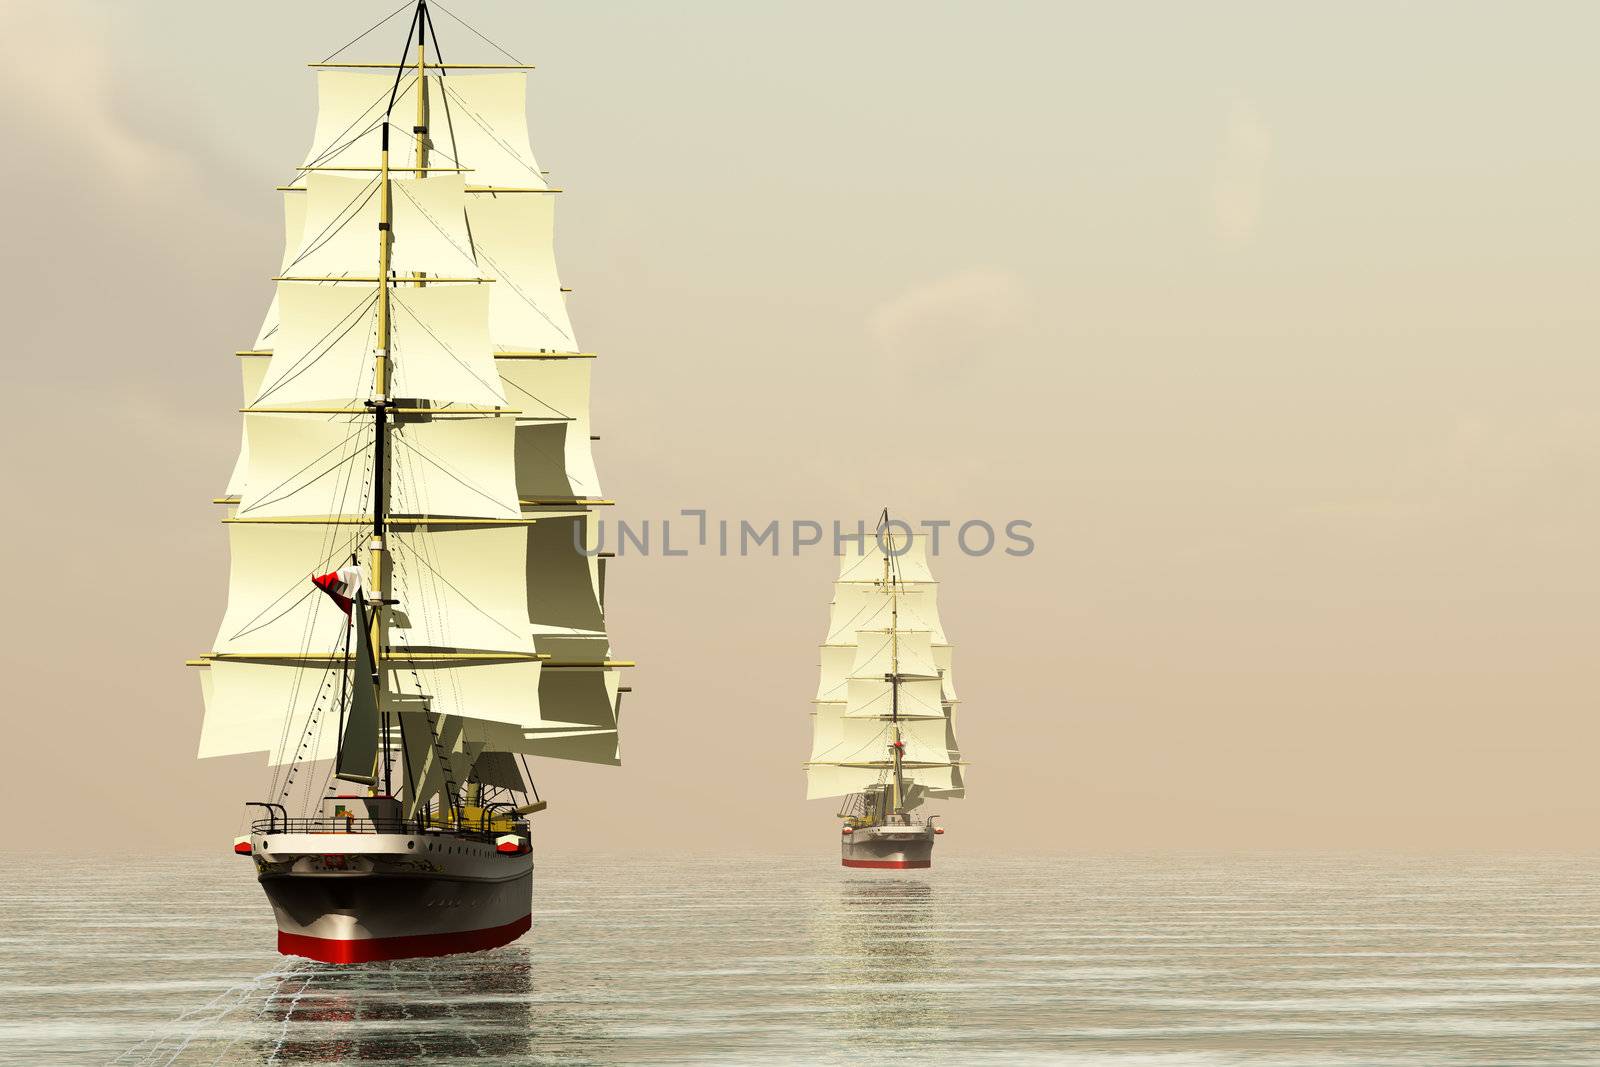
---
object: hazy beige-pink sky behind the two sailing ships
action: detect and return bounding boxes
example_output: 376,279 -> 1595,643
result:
0,0 -> 1600,854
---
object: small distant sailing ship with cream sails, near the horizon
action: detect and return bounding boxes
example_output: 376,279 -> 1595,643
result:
806,510 -> 966,869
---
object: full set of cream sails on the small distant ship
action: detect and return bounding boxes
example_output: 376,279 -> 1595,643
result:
806,526 -> 965,808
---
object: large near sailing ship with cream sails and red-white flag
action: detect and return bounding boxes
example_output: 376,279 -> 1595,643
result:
190,0 -> 630,963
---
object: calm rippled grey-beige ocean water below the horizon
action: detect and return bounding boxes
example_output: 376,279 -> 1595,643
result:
0,838 -> 1600,1065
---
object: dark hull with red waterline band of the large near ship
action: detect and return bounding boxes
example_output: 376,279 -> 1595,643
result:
256,833 -> 533,963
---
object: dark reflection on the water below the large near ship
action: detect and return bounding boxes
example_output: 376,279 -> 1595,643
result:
246,945 -> 597,1064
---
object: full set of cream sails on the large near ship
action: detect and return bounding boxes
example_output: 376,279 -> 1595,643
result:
200,62 -> 624,796
